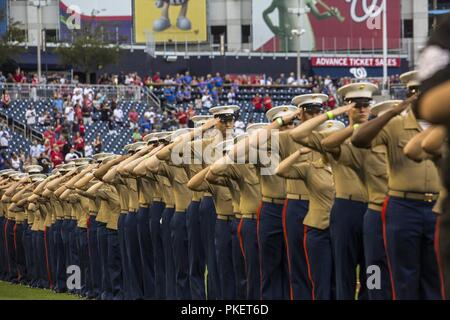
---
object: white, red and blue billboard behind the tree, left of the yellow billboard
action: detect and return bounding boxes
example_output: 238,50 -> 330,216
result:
59,0 -> 133,43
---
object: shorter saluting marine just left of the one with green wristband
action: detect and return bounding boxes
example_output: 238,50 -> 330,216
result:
277,121 -> 344,300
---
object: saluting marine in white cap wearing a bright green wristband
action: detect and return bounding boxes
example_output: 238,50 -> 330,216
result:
291,83 -> 378,300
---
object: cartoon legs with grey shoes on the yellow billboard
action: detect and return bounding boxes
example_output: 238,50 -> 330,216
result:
153,0 -> 192,32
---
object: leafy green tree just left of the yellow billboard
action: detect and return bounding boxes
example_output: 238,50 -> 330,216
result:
55,23 -> 120,83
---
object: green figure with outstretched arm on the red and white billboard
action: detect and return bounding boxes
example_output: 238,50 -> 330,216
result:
263,0 -> 345,51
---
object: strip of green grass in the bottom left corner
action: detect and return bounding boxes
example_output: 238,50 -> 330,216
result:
0,281 -> 82,300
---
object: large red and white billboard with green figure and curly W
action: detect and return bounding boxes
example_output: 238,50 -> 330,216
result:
252,0 -> 401,52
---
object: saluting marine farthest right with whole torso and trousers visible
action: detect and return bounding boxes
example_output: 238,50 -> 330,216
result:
352,74 -> 441,300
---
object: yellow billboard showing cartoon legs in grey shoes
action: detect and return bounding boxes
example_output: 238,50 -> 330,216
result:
134,0 -> 207,43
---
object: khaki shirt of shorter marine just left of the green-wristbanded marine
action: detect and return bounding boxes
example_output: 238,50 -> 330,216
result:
288,161 -> 334,230
